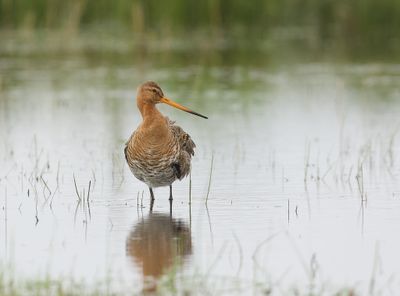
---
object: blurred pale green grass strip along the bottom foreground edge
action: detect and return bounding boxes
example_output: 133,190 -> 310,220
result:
0,268 -> 360,296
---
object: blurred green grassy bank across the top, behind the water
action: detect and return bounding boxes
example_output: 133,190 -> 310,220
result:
0,0 -> 400,54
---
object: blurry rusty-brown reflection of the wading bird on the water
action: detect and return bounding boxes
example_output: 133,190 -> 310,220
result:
126,212 -> 192,292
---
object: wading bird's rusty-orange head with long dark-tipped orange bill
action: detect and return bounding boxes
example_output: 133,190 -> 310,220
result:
137,81 -> 208,119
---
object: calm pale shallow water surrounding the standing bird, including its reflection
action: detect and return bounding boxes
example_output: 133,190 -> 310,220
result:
0,31 -> 400,294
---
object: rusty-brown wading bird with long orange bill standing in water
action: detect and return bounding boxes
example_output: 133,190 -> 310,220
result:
124,81 -> 208,209
